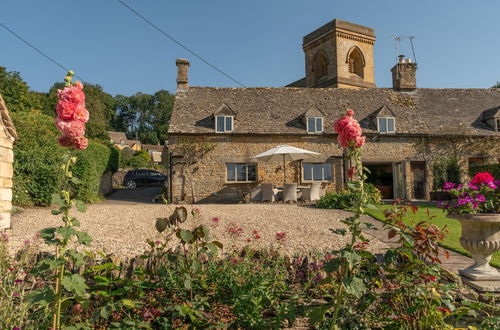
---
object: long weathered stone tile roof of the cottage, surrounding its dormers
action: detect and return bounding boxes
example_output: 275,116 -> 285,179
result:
169,87 -> 500,136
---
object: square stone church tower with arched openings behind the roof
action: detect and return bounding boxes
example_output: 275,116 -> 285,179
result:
300,19 -> 376,88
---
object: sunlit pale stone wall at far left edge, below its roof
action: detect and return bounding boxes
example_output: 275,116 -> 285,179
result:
0,124 -> 14,229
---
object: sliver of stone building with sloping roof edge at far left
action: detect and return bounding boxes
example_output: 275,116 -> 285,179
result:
0,95 -> 17,230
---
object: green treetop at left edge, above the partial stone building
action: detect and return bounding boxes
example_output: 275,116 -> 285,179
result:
0,66 -> 32,112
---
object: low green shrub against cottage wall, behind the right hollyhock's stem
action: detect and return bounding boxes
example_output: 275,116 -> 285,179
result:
316,183 -> 382,210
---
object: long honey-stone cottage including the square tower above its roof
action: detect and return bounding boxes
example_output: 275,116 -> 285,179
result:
168,20 -> 500,202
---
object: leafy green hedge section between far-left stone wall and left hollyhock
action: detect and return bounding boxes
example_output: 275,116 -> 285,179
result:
12,111 -> 64,206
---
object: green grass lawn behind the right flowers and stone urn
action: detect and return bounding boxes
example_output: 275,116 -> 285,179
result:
365,204 -> 500,268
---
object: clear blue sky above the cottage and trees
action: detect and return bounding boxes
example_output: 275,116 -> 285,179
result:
0,0 -> 500,95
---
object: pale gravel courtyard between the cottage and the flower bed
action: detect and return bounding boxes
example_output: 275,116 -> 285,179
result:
8,202 -> 387,256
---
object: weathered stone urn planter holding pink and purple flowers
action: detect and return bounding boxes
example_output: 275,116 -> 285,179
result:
448,213 -> 500,281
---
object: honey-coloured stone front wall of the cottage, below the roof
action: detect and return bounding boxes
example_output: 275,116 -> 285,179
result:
169,134 -> 500,202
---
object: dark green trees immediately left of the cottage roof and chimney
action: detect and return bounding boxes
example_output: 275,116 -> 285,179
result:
114,90 -> 174,144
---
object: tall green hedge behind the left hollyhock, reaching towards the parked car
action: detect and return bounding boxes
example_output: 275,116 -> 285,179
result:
12,111 -> 119,206
